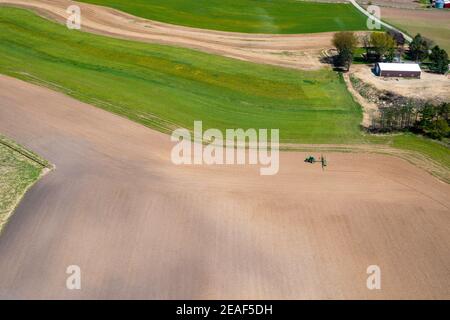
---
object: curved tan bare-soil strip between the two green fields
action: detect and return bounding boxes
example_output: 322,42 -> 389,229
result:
0,0 -> 333,70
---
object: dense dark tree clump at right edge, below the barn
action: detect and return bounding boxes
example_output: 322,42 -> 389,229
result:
372,100 -> 450,140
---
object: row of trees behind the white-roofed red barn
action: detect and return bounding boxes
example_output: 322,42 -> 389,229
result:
333,30 -> 449,74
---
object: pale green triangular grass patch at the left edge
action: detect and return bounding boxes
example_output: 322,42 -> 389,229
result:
0,135 -> 51,233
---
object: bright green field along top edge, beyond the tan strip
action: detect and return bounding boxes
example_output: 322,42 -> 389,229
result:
76,0 -> 366,33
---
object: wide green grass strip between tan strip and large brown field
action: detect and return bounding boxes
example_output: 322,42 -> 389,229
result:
0,8 -> 361,143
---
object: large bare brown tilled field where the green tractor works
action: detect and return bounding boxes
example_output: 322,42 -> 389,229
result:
0,76 -> 450,299
